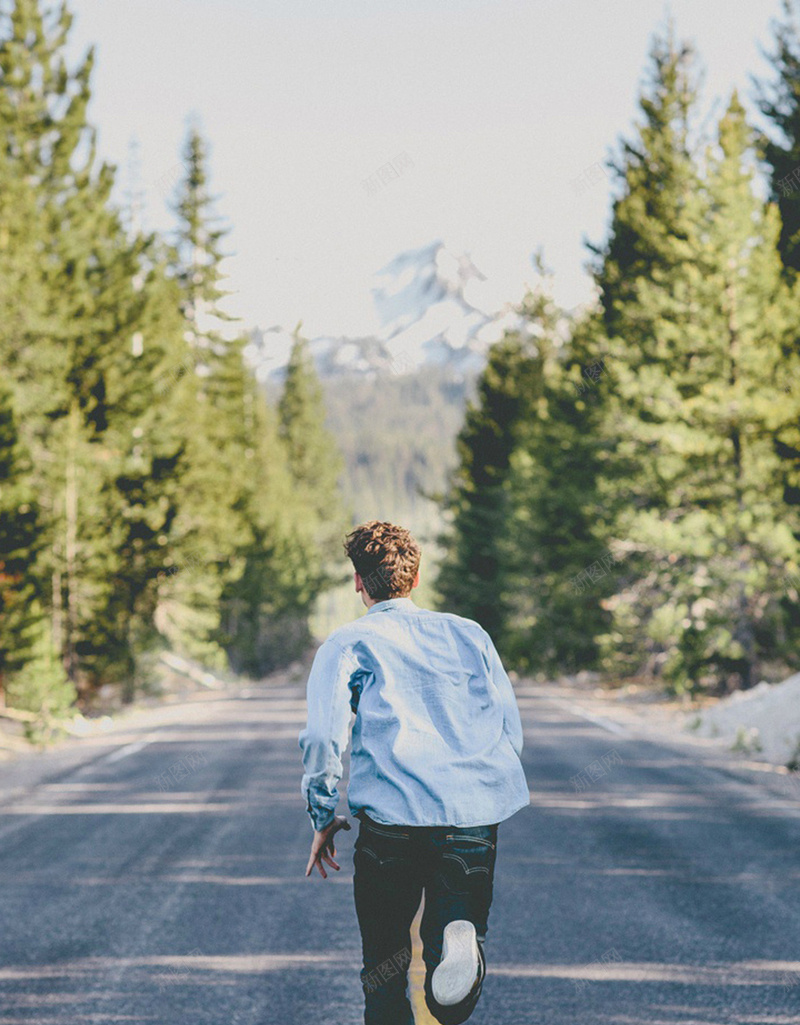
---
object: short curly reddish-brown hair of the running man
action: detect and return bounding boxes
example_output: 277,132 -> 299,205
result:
345,520 -> 422,602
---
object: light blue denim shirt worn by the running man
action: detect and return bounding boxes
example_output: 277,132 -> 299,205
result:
299,598 -> 530,829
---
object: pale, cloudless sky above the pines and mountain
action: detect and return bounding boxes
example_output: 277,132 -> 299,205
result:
71,0 -> 779,336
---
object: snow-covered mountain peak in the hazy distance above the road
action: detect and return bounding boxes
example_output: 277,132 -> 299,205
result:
250,241 -> 537,381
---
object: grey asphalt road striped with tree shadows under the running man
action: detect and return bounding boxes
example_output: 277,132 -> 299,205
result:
0,672 -> 800,1025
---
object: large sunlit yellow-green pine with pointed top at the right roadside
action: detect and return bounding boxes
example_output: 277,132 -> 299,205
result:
605,95 -> 798,689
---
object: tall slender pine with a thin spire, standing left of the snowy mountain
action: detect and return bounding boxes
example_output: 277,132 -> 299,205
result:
157,125 -> 248,668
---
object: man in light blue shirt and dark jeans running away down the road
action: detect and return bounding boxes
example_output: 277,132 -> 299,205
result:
299,520 -> 530,1025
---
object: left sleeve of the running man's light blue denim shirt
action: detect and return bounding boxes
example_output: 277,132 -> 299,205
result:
299,638 -> 358,830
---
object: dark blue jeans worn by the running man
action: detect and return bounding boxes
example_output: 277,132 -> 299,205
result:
353,812 -> 497,1025
